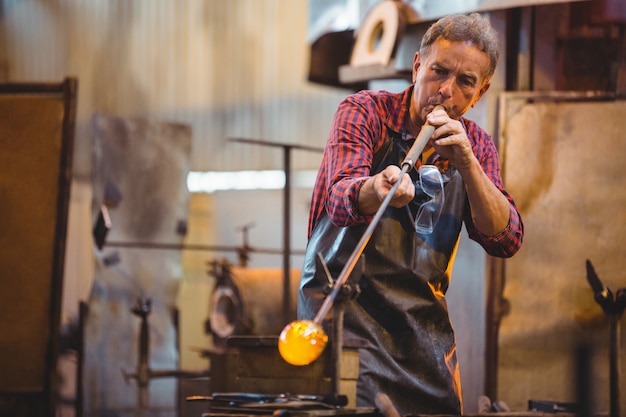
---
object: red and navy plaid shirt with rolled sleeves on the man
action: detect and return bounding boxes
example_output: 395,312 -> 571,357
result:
308,85 -> 524,257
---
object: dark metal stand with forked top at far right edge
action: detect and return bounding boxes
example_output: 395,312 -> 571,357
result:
587,260 -> 626,417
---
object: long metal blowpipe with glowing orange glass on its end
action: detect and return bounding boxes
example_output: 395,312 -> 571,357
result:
278,105 -> 444,365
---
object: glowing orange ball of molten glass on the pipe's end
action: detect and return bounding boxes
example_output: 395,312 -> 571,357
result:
278,320 -> 328,366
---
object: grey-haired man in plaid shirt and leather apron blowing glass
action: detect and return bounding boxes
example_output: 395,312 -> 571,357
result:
298,14 -> 523,415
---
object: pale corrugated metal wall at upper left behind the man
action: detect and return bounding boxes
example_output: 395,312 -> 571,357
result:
0,0 -> 348,177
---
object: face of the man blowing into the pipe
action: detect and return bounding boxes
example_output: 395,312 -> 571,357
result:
411,39 -> 489,124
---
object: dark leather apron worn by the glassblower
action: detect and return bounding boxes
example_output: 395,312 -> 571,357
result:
298,129 -> 467,415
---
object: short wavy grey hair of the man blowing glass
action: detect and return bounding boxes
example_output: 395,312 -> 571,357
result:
420,13 -> 500,79
